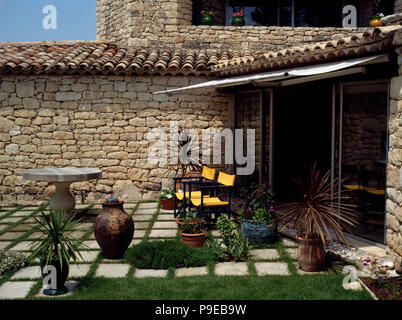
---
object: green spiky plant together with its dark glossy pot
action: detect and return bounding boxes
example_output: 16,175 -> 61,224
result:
28,211 -> 86,296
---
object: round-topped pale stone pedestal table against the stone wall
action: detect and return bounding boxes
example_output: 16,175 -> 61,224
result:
22,168 -> 102,213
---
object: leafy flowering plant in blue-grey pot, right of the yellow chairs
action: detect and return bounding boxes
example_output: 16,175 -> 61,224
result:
240,184 -> 277,243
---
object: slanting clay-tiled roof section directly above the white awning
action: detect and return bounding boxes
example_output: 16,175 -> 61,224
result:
211,25 -> 402,76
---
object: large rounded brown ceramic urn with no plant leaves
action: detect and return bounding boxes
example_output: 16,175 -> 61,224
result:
94,198 -> 134,259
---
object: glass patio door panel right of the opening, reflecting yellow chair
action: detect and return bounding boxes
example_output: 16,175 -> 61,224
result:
334,82 -> 389,243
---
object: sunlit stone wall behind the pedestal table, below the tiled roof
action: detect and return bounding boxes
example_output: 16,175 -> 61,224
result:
0,76 -> 230,205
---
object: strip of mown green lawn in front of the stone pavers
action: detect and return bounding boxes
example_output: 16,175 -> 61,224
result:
33,274 -> 371,300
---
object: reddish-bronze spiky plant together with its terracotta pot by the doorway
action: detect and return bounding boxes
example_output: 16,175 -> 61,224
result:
276,164 -> 358,272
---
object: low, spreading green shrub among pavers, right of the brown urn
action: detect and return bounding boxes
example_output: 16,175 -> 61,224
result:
126,240 -> 216,269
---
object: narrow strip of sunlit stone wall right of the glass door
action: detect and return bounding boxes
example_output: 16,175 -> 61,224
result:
386,32 -> 402,272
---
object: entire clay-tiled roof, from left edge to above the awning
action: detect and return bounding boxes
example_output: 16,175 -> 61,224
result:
0,25 -> 402,77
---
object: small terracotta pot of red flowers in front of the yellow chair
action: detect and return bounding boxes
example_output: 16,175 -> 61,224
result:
180,213 -> 207,247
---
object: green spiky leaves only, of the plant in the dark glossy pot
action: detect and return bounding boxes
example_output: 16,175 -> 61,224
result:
28,211 -> 86,269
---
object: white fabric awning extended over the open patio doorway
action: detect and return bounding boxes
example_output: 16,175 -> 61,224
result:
153,54 -> 388,94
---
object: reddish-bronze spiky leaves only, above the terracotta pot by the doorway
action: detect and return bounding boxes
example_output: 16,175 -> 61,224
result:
275,164 -> 358,247
